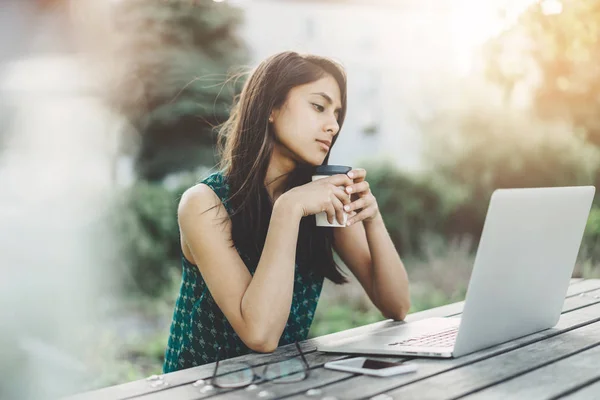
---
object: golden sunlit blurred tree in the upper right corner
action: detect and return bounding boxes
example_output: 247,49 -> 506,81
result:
487,0 -> 600,146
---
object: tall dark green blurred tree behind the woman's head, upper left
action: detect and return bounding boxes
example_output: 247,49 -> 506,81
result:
110,0 -> 247,180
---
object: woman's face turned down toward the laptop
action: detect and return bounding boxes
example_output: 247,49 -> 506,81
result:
269,74 -> 341,165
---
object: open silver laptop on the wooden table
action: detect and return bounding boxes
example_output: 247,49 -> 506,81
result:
317,186 -> 595,358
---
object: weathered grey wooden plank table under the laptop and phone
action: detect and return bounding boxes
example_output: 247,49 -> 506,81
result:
70,279 -> 600,400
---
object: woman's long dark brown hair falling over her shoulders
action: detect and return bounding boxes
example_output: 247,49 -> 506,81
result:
219,51 -> 348,284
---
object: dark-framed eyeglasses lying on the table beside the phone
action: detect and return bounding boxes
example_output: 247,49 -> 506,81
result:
204,342 -> 309,389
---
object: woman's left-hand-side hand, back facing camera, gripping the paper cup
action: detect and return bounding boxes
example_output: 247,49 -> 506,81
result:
277,174 -> 353,224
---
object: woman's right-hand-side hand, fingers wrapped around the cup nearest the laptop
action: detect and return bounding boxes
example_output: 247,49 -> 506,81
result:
344,168 -> 381,226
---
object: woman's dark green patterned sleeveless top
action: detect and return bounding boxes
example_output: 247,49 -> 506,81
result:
163,172 -> 323,373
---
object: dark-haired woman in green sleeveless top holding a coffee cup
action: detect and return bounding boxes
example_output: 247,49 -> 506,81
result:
164,52 -> 410,372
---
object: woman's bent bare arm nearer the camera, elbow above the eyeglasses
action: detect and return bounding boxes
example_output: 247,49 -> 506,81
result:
178,184 -> 301,352
